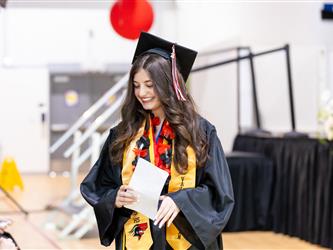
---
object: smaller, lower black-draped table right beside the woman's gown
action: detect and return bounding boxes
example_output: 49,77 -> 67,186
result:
224,152 -> 273,232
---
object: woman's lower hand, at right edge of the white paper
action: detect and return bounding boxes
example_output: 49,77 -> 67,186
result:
154,195 -> 180,228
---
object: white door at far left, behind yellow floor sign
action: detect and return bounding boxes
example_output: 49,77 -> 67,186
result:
0,68 -> 49,173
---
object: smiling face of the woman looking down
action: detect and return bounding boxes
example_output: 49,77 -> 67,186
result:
133,69 -> 163,117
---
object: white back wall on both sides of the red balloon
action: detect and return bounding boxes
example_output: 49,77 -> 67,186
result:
0,1 -> 333,166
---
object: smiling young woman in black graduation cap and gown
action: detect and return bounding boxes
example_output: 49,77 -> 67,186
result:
81,33 -> 233,250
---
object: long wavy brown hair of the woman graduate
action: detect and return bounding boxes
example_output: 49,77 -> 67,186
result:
110,54 -> 208,173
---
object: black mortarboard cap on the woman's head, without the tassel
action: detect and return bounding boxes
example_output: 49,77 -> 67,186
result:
132,32 -> 198,82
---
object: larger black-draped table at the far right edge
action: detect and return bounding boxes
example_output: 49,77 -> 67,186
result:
233,135 -> 333,248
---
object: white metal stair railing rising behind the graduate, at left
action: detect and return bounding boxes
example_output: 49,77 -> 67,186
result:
45,74 -> 129,239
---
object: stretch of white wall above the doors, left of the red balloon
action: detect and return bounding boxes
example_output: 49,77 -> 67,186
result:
2,8 -> 135,66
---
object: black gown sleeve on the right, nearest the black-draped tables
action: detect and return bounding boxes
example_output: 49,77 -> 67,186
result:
168,127 -> 234,249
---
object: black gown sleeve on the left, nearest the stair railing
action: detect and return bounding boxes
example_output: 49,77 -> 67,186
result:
80,130 -> 131,246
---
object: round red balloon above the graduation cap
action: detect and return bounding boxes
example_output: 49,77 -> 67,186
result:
110,0 -> 154,40
